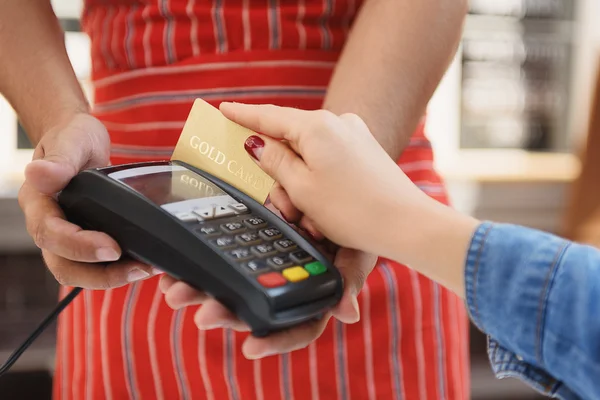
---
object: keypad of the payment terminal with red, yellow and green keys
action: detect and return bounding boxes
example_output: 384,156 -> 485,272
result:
188,203 -> 327,289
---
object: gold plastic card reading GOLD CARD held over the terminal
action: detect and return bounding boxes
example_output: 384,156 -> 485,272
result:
171,99 -> 275,204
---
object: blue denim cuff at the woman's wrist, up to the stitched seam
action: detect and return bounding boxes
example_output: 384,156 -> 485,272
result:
465,221 -> 568,367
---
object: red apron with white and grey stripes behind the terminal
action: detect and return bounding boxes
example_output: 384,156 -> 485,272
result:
54,0 -> 469,400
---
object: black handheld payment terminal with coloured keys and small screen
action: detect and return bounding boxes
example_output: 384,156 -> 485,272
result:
58,161 -> 342,336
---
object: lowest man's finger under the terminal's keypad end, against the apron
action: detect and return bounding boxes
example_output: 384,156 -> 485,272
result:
242,314 -> 331,360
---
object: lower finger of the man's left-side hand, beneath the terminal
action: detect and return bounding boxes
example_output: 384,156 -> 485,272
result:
42,250 -> 158,290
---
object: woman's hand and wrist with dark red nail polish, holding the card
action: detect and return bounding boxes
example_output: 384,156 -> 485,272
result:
221,103 -> 479,296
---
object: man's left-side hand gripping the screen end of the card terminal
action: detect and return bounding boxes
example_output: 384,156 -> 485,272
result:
19,113 -> 159,289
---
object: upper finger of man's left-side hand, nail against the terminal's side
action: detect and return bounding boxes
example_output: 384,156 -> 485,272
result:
19,182 -> 121,262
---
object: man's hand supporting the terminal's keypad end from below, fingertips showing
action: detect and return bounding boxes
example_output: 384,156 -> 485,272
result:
160,248 -> 377,359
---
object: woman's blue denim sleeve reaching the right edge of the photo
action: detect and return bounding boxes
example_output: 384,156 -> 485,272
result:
465,222 -> 600,399
